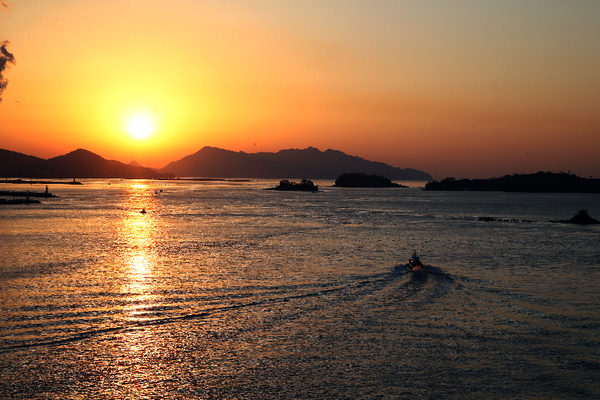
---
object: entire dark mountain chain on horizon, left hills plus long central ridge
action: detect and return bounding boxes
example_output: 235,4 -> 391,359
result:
0,147 -> 432,181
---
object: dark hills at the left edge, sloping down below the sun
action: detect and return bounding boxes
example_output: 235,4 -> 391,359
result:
0,149 -> 173,179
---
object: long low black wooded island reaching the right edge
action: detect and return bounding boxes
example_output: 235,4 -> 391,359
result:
425,171 -> 600,193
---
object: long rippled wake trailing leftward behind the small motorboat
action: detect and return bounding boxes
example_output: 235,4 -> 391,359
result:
0,265 -> 453,353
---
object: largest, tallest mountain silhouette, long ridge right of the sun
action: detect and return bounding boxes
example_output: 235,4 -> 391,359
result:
159,147 -> 432,181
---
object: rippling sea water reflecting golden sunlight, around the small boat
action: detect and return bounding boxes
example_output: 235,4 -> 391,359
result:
0,180 -> 600,399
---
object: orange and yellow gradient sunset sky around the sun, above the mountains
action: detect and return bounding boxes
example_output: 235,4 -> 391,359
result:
0,0 -> 600,179
